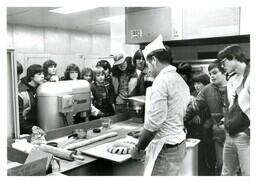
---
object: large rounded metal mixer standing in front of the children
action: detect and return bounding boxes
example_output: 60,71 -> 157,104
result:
37,80 -> 91,131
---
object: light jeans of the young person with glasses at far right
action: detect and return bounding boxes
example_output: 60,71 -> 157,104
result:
221,132 -> 250,176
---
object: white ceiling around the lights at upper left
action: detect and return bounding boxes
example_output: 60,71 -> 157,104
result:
7,7 -> 125,34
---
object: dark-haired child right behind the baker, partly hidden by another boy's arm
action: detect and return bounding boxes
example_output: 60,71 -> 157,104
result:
185,73 -> 212,176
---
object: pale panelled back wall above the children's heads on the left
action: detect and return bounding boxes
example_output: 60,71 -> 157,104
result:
7,24 -> 110,76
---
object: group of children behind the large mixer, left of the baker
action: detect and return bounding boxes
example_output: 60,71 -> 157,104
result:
17,49 -> 152,134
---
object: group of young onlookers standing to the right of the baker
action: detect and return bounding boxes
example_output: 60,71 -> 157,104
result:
177,45 -> 250,175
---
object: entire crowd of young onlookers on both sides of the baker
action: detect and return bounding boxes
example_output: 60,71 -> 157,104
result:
17,45 -> 250,175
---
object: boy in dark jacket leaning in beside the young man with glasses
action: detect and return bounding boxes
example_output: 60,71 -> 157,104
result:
184,60 -> 227,175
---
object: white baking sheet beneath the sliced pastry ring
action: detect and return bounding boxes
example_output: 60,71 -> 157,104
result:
81,136 -> 138,163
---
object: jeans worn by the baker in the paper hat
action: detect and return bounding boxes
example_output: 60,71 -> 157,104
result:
152,142 -> 186,176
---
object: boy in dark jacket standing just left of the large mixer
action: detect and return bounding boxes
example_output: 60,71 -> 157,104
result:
18,64 -> 44,134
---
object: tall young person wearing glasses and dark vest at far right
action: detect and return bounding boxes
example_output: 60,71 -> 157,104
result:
218,44 -> 251,176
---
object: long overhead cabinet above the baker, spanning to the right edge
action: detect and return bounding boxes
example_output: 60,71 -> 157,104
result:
126,7 -> 245,44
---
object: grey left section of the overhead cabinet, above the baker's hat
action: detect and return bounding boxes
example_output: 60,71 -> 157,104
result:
125,8 -> 172,44
